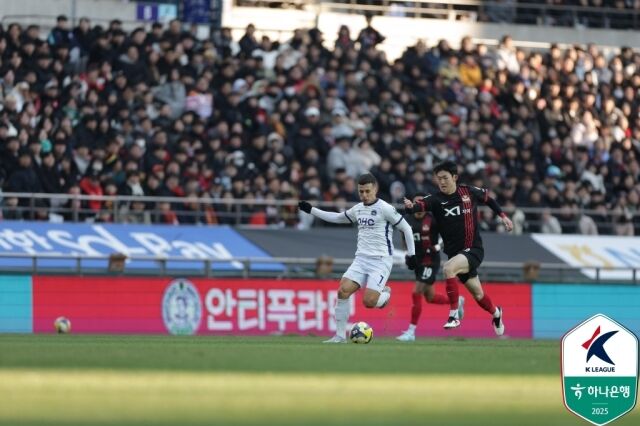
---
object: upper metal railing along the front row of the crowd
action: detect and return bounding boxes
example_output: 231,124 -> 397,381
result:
0,192 -> 640,235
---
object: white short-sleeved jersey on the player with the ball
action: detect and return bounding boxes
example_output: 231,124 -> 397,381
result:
344,199 -> 402,256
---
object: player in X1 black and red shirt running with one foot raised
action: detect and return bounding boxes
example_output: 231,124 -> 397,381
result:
404,161 -> 513,336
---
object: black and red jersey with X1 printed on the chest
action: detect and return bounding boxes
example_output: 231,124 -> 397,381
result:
417,185 -> 489,257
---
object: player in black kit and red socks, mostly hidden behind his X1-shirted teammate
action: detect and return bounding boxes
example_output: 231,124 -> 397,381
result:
396,194 -> 464,342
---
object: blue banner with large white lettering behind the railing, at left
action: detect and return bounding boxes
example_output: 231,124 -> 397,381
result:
0,221 -> 282,271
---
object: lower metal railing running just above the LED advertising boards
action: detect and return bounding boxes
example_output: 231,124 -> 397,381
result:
0,253 -> 640,285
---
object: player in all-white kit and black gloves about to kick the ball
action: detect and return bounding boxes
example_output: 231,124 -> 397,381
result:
298,173 -> 416,343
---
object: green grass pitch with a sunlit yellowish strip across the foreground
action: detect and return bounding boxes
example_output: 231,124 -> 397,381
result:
0,335 -> 640,426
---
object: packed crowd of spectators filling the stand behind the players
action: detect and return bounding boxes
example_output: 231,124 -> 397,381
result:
0,16 -> 640,235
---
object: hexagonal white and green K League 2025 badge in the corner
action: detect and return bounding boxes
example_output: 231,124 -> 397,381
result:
562,314 -> 638,425
